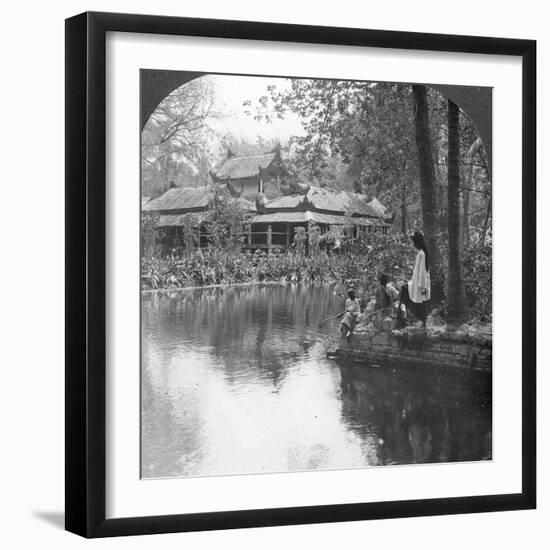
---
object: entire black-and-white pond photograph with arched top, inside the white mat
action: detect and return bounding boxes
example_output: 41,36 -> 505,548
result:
140,69 -> 493,480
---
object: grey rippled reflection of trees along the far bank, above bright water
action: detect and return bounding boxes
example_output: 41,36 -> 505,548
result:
142,285 -> 343,387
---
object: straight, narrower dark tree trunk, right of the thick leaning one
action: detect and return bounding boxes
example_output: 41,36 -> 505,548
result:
447,101 -> 469,322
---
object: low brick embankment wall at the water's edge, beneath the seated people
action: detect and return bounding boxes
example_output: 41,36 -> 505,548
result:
334,328 -> 493,370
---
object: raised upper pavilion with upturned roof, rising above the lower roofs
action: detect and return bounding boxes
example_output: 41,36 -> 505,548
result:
211,147 -> 288,201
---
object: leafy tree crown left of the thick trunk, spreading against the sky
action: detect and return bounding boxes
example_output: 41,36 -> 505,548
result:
248,79 -> 417,209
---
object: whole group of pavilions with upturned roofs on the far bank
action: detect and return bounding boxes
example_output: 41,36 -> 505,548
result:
142,175 -> 392,254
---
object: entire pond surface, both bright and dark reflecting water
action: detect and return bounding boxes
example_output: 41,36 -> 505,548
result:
141,285 -> 492,478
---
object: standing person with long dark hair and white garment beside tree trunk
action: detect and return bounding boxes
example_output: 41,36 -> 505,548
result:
399,231 -> 431,328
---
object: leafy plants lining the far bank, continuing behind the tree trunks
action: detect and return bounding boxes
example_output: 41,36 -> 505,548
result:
141,236 -> 492,322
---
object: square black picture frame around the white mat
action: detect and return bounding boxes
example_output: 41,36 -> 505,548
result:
65,13 -> 536,537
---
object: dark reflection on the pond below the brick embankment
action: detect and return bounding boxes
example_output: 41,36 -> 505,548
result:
340,365 -> 492,464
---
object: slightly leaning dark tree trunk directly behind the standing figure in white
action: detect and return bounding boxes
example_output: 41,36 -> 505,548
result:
412,84 -> 443,302
